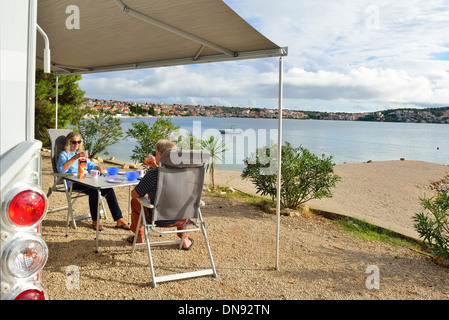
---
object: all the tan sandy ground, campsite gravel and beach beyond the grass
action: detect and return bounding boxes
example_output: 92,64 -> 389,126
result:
41,154 -> 449,300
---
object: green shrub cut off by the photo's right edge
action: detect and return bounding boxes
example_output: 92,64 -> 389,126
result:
413,192 -> 449,260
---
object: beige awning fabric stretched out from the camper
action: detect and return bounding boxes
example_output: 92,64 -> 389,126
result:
36,0 -> 287,75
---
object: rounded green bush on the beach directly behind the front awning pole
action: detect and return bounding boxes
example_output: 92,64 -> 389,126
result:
242,142 -> 341,209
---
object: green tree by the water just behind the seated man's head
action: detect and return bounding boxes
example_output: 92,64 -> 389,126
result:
126,118 -> 179,163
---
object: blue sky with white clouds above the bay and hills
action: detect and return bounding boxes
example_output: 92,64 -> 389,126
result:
80,0 -> 449,112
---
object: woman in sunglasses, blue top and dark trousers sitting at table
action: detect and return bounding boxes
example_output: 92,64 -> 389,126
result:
56,132 -> 130,230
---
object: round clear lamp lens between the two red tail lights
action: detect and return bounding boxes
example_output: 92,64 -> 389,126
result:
2,235 -> 48,278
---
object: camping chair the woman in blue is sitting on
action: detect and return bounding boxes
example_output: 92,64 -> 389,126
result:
47,129 -> 106,235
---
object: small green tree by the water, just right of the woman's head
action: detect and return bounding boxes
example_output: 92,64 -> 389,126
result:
78,113 -> 123,158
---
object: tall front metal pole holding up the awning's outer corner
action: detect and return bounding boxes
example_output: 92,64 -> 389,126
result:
276,57 -> 283,270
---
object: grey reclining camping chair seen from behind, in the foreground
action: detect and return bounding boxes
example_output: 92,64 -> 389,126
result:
132,149 -> 217,287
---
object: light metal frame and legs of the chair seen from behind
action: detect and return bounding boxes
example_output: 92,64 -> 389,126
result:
132,150 -> 218,288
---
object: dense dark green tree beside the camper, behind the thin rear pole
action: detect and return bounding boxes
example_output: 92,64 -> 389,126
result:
34,69 -> 84,146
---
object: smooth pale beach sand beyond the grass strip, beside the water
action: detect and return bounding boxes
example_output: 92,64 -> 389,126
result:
210,160 -> 449,238
